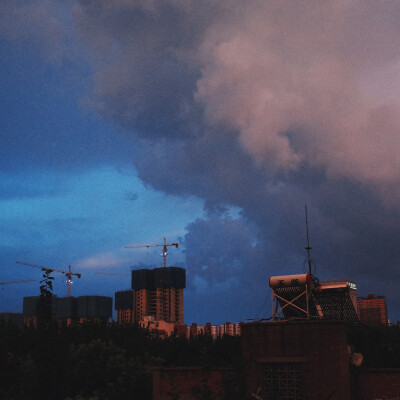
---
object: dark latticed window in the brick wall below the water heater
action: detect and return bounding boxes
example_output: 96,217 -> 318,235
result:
263,362 -> 304,400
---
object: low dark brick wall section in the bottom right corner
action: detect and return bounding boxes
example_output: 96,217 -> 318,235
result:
357,368 -> 400,400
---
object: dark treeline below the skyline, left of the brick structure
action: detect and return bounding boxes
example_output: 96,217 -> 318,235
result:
0,323 -> 241,400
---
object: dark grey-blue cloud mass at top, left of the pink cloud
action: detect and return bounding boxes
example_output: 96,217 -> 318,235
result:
74,1 -> 215,140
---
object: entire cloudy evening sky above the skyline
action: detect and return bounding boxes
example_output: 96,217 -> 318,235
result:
0,0 -> 400,323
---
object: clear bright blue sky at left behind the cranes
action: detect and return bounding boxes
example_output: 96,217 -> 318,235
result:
0,35 -> 208,318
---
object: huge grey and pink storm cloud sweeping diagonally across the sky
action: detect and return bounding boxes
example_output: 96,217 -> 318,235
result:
1,0 -> 400,318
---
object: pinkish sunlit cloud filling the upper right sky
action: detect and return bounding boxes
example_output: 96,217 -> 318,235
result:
196,1 -> 400,185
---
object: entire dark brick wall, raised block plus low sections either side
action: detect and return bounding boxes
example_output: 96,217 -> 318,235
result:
153,320 -> 400,400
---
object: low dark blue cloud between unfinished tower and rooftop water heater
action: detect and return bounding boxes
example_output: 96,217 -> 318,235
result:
183,215 -> 271,322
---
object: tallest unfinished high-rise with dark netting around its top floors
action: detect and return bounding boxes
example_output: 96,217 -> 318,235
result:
115,267 -> 186,324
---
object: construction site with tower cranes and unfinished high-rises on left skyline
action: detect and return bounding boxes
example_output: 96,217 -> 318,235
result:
11,238 -> 186,330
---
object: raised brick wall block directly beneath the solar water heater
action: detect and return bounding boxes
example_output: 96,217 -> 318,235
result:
242,320 -> 351,400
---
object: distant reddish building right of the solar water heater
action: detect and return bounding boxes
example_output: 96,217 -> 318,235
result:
357,294 -> 388,325
